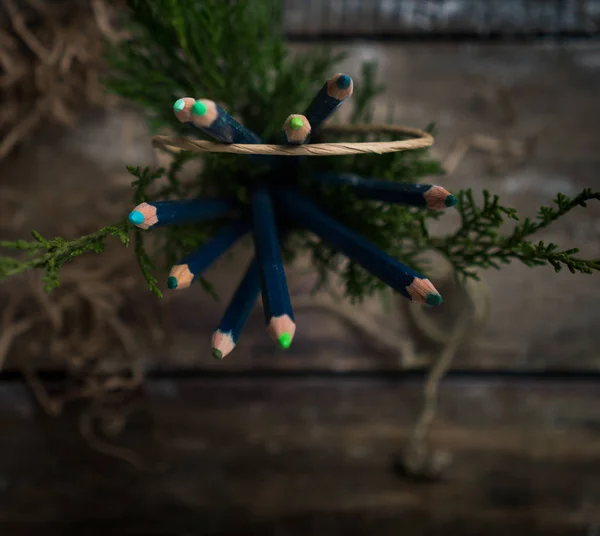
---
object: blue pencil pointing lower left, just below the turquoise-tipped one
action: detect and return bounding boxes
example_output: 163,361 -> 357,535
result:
167,219 -> 250,290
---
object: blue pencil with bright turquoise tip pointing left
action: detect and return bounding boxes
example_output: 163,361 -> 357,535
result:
129,199 -> 235,229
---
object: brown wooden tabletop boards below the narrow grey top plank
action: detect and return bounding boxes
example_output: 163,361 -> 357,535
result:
0,40 -> 600,536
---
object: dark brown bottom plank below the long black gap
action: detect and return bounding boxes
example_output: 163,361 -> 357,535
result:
0,379 -> 600,536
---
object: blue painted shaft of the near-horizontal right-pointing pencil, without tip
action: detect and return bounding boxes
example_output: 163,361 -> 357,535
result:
312,173 -> 432,207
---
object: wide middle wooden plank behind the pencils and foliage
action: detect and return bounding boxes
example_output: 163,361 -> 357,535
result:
0,43 -> 600,371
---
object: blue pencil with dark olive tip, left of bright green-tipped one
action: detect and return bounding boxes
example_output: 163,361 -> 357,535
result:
212,258 -> 260,359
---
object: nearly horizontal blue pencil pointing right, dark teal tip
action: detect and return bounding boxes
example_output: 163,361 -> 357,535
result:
310,172 -> 456,210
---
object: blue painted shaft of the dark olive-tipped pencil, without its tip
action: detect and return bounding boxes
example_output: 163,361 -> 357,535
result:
218,258 -> 260,343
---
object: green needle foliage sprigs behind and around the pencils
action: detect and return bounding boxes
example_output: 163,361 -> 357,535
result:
0,0 -> 600,299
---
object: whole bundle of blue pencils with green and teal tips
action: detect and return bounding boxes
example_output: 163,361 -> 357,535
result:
129,74 -> 456,359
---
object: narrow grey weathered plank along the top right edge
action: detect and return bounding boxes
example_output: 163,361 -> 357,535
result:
284,0 -> 600,38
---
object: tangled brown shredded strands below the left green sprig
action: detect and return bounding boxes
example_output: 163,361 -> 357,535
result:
0,248 -> 168,468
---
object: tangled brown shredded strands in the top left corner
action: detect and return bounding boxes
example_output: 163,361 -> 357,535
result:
0,0 -> 123,160
